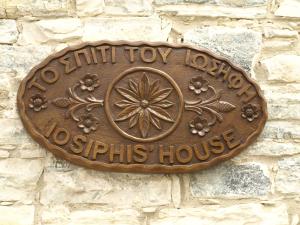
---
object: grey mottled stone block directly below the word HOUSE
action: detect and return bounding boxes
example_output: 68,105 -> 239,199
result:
190,163 -> 271,198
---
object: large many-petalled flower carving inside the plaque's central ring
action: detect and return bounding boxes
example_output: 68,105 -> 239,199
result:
115,72 -> 174,138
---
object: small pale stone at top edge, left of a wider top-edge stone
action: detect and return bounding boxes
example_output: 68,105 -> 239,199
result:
76,0 -> 104,16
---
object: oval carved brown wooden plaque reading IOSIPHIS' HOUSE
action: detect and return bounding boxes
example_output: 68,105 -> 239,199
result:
18,41 -> 267,173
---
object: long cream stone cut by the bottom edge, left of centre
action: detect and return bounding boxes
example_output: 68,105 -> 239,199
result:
41,205 -> 141,225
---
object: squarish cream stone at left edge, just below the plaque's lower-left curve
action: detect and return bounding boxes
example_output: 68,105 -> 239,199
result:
0,158 -> 43,202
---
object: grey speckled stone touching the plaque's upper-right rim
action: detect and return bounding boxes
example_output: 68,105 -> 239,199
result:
184,26 -> 262,71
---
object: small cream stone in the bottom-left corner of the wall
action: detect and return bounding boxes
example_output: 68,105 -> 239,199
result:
0,206 -> 34,225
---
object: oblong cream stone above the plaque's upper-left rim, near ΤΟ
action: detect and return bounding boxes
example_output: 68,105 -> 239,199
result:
18,18 -> 83,45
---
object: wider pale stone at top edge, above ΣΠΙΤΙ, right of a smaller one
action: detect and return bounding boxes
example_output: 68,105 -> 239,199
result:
105,0 -> 152,16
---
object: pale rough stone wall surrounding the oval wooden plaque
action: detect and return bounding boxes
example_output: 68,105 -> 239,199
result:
0,0 -> 300,225
